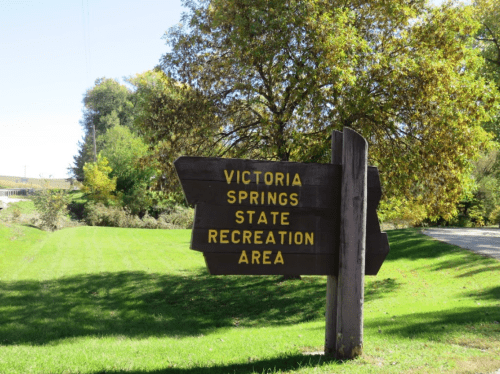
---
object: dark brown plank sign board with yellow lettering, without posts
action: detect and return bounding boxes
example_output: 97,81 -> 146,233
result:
174,157 -> 389,275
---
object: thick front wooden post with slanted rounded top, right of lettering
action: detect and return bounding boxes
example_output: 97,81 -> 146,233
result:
336,128 -> 368,359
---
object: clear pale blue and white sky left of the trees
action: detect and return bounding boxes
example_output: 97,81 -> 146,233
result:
0,0 -> 184,178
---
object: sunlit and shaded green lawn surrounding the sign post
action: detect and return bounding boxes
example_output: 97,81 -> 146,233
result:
0,224 -> 500,374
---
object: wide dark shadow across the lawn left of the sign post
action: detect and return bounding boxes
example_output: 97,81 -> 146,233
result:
0,270 -> 326,345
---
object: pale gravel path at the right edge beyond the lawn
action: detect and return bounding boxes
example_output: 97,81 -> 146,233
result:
422,228 -> 500,260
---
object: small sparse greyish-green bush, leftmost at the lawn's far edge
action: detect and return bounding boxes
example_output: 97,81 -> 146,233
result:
33,188 -> 69,231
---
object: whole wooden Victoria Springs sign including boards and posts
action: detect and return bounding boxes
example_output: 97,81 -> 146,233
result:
174,128 -> 389,359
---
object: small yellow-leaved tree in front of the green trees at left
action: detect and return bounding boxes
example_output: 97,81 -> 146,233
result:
81,154 -> 117,204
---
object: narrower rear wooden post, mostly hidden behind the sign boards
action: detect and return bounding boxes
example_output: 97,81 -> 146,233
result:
325,131 -> 342,356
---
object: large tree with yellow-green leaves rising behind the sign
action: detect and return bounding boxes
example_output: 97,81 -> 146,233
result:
151,0 -> 498,216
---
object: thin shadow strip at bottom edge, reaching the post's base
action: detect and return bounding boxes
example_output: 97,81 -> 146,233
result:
90,354 -> 342,374
